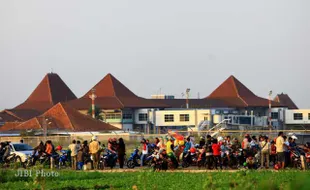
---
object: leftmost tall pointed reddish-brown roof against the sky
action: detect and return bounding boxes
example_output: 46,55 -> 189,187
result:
14,73 -> 76,111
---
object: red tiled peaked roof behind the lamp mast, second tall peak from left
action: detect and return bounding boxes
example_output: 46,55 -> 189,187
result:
69,74 -> 168,110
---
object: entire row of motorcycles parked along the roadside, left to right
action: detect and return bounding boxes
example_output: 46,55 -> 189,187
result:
0,147 -> 310,170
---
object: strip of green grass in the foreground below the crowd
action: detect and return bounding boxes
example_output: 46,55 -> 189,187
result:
0,170 -> 310,190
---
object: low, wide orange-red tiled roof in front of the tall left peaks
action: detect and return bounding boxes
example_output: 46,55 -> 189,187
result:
0,103 -> 120,132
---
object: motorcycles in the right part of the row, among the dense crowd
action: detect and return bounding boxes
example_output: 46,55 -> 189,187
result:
127,144 -> 310,170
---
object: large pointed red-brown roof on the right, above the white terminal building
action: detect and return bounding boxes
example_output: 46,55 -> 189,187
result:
205,75 -> 281,107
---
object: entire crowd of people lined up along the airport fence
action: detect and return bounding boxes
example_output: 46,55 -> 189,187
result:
0,132 -> 309,170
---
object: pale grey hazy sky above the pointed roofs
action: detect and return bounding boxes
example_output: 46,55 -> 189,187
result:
0,0 -> 310,110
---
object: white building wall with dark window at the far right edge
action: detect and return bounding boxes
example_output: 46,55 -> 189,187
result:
285,109 -> 310,124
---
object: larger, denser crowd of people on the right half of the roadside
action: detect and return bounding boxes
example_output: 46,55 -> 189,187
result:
141,132 -> 309,169
